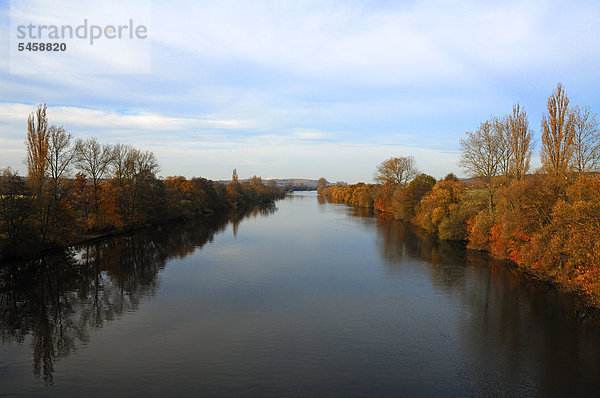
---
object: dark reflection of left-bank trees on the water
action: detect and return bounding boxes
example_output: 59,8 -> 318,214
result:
0,204 -> 277,384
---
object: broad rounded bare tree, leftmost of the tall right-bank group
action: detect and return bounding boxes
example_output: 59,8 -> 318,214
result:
459,121 -> 501,211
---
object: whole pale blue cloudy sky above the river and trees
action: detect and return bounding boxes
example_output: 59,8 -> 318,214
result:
0,0 -> 600,183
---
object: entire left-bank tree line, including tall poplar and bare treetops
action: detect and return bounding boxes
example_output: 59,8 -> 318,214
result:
0,104 -> 285,258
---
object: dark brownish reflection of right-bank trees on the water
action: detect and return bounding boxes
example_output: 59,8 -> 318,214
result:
348,204 -> 600,396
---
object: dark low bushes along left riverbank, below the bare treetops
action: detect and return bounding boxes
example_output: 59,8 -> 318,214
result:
0,176 -> 286,261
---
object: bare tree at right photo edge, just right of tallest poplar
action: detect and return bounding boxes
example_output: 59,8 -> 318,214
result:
572,106 -> 600,173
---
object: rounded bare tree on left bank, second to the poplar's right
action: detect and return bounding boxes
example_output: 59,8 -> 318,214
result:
75,137 -> 112,214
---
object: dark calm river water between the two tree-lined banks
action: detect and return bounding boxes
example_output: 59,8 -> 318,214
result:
0,193 -> 600,397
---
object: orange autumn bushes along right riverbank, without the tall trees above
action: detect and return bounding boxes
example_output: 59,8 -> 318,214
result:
320,174 -> 600,309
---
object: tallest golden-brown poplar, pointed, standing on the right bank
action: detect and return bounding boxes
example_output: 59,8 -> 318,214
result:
541,83 -> 575,175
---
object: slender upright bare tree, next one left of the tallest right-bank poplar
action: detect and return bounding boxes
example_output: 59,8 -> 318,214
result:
508,103 -> 532,179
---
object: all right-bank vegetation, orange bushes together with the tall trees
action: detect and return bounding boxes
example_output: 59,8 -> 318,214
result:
318,83 -> 600,309
